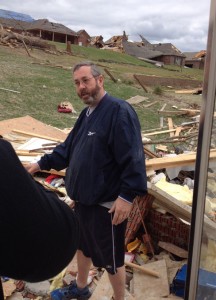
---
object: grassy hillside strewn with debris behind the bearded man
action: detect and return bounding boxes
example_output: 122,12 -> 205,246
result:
0,44 -> 203,130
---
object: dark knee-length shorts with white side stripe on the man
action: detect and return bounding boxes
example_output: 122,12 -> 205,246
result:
75,202 -> 127,274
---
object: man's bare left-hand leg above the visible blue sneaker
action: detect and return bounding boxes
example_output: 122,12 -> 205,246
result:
76,250 -> 92,288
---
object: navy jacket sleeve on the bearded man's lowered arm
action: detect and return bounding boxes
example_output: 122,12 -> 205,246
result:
113,103 -> 147,202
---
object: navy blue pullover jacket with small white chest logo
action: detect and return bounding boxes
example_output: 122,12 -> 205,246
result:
38,94 -> 147,205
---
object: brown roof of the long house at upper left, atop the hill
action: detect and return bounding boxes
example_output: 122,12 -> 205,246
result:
26,19 -> 77,36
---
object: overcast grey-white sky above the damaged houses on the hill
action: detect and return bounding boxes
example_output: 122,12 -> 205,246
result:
0,0 -> 214,52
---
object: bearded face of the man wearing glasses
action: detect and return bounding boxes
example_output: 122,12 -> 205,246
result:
74,66 -> 104,106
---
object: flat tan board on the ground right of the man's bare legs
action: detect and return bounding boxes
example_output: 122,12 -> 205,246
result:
133,259 -> 170,299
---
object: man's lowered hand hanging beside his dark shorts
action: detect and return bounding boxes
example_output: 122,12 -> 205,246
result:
109,198 -> 132,225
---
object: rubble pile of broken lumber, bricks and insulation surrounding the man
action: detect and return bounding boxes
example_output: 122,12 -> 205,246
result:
0,111 -> 216,300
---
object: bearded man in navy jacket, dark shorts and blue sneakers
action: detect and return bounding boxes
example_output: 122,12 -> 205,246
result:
26,62 -> 146,300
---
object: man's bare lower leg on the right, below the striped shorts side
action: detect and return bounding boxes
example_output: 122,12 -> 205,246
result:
108,266 -> 126,300
